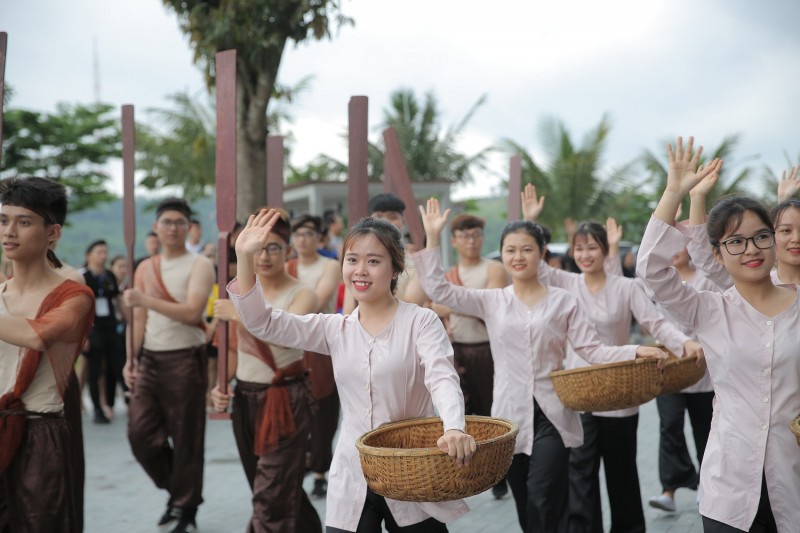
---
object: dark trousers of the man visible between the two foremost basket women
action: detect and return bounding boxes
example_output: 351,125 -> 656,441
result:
453,342 -> 494,416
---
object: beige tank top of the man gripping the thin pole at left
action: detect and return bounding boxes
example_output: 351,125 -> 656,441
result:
144,253 -> 206,352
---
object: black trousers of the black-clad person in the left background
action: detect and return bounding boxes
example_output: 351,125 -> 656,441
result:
86,324 -> 123,413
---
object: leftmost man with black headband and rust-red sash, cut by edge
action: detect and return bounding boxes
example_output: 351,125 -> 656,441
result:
0,178 -> 94,533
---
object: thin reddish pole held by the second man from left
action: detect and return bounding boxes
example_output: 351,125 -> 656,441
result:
122,104 -> 138,368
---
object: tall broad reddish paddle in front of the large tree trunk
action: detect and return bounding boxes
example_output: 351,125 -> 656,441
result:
209,50 -> 236,420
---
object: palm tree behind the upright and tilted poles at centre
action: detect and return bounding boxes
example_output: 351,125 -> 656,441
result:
298,89 -> 493,183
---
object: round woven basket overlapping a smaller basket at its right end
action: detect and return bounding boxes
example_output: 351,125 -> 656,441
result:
550,359 -> 663,412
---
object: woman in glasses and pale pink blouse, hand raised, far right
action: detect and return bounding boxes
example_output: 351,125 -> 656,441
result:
637,137 -> 800,533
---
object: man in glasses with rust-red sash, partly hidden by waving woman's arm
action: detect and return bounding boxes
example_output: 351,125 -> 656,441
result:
216,208 -> 322,533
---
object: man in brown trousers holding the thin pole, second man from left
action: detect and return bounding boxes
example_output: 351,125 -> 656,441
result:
123,198 -> 214,533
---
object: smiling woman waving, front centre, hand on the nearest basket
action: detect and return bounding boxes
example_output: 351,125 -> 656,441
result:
228,210 -> 476,533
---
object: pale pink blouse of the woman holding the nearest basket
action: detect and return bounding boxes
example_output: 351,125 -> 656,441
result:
228,280 -> 469,531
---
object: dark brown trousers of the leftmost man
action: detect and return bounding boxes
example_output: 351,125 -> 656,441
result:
0,417 -> 81,533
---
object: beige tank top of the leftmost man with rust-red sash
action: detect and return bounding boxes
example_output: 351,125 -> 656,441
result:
0,283 -> 64,413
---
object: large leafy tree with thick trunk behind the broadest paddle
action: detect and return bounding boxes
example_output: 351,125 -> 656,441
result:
163,0 -> 352,218
